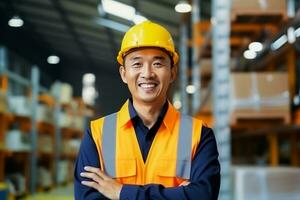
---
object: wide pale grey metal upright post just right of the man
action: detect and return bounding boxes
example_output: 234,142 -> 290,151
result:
212,0 -> 233,200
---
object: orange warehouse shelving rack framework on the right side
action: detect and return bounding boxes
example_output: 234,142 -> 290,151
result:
192,1 -> 300,169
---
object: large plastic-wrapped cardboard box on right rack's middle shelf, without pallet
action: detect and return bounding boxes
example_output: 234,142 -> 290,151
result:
230,72 -> 290,112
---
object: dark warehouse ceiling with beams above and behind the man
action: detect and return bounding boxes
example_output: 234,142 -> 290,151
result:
0,0 -> 210,115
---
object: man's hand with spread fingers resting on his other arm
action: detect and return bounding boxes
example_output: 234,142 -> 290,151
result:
80,166 -> 123,199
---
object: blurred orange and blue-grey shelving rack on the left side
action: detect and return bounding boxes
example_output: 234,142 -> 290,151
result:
0,47 -> 83,195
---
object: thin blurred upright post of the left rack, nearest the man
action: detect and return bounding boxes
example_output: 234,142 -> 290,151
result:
54,82 -> 61,185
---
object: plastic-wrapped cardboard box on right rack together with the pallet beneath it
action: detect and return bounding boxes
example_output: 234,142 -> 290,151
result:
230,72 -> 291,124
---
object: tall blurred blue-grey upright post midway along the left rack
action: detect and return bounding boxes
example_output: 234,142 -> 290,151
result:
30,66 -> 40,193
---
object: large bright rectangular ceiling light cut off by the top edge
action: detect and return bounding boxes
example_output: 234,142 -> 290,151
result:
102,0 -> 135,20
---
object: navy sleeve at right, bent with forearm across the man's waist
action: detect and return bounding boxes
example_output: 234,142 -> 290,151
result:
120,126 -> 220,200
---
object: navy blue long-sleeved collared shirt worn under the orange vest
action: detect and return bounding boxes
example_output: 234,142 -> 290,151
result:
74,101 -> 220,200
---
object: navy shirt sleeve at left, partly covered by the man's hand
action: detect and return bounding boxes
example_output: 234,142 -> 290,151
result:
74,129 -> 107,200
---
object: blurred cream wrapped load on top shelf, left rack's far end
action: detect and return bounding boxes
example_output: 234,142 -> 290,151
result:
51,82 -> 73,104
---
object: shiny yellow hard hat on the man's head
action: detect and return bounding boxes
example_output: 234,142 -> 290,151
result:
117,21 -> 178,65
